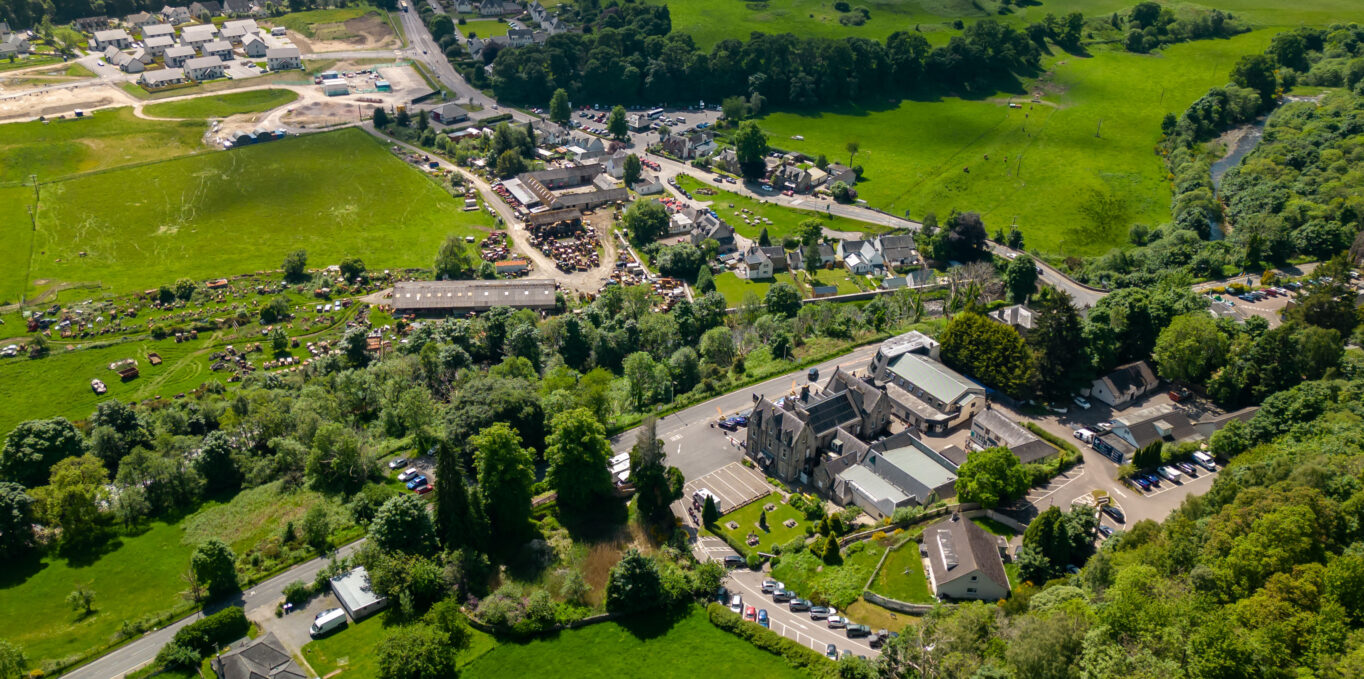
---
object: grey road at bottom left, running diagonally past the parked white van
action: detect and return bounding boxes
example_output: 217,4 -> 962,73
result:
61,539 -> 364,679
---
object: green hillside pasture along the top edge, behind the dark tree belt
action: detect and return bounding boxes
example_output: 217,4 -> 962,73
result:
665,0 -> 1364,48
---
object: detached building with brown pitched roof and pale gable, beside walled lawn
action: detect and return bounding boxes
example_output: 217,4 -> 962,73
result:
919,514 -> 1009,601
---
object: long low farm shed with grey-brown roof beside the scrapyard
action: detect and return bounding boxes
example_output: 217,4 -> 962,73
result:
393,278 -> 555,315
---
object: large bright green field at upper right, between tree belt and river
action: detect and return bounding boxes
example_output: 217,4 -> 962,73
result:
760,30 -> 1274,256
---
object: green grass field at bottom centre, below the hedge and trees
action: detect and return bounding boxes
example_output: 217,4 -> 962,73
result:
464,608 -> 809,679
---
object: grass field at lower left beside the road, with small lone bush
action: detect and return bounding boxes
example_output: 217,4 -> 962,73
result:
0,520 -> 192,665
